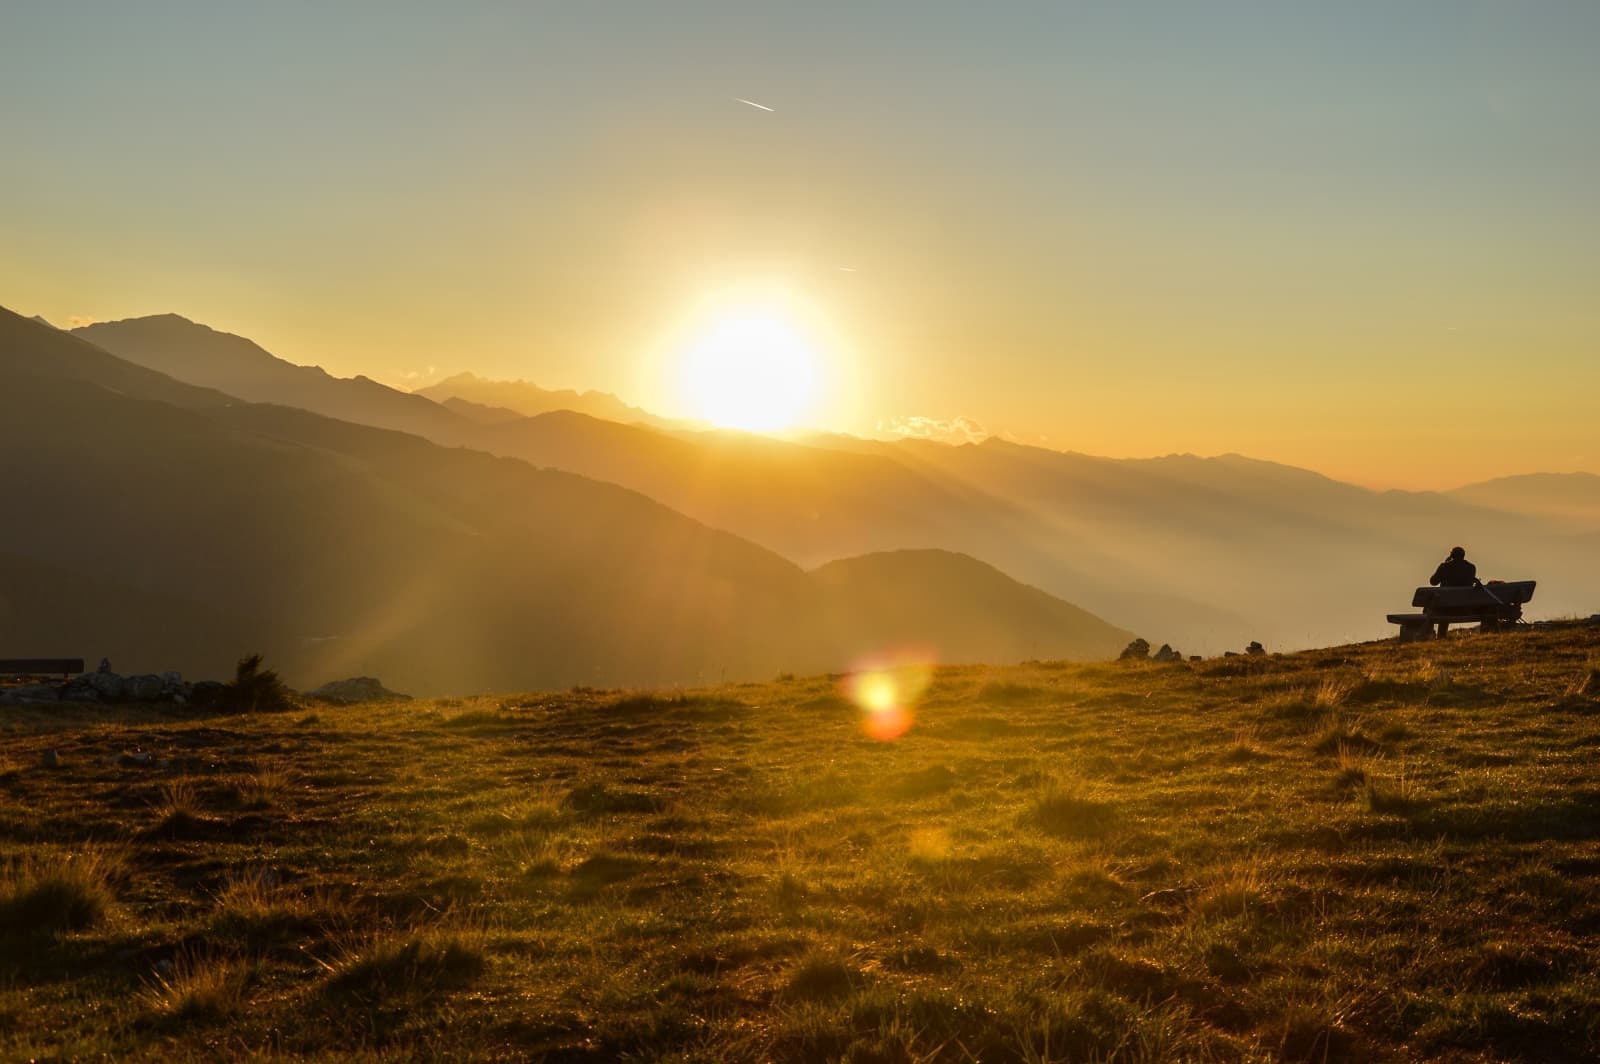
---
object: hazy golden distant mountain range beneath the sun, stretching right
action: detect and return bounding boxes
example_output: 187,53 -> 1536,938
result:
50,308 -> 1600,653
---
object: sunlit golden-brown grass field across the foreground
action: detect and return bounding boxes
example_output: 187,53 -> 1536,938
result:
0,626 -> 1600,1061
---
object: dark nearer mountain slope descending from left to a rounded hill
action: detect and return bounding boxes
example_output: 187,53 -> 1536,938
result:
0,310 -> 1131,693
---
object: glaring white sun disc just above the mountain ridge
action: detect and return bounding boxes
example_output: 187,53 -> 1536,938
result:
682,312 -> 819,432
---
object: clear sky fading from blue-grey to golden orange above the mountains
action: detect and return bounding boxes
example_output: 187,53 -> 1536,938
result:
0,0 -> 1600,488
